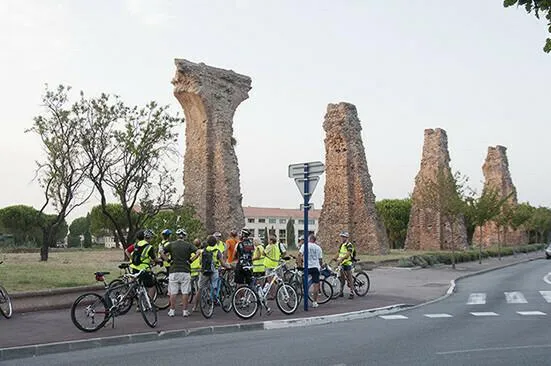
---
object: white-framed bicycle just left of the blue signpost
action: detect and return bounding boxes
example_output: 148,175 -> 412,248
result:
232,258 -> 299,319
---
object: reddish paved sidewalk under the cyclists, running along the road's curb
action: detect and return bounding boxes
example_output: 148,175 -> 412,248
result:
0,251 -> 545,352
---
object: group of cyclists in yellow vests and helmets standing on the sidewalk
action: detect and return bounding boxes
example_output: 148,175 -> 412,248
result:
125,228 -> 355,317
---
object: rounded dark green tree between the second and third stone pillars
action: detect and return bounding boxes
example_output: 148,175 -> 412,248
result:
375,198 -> 411,249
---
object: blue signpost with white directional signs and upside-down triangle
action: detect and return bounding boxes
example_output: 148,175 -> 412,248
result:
289,161 -> 325,311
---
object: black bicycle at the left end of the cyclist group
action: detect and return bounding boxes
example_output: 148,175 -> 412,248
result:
71,269 -> 157,332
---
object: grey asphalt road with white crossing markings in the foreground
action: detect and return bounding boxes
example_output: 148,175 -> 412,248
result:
4,261 -> 551,366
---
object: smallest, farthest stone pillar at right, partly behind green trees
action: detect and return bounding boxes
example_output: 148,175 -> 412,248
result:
473,145 -> 528,246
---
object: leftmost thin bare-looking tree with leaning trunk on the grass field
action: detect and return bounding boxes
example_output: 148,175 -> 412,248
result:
26,85 -> 93,261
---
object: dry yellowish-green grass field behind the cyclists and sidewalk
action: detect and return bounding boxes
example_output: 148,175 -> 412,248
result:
0,249 -> 426,292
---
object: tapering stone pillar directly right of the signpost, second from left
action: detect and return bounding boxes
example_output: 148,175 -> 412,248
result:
318,103 -> 389,254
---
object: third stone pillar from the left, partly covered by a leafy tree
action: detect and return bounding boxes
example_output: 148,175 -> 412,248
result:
405,128 -> 467,250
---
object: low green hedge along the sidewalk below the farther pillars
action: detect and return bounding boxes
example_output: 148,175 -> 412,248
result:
398,244 -> 546,267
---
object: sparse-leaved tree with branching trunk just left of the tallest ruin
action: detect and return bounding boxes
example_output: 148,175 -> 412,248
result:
74,92 -> 183,248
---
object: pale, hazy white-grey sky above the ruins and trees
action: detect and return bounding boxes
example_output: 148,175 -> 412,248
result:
0,0 -> 551,222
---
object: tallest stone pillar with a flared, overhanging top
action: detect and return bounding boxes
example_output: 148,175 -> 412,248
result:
172,59 -> 251,235
